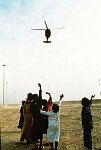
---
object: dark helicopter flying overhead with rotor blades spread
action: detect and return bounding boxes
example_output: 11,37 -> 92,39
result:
31,21 -> 63,43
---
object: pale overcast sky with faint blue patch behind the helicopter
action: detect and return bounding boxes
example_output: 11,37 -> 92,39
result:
0,0 -> 101,103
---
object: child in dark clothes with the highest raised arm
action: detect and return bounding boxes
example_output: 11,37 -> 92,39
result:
30,83 -> 43,149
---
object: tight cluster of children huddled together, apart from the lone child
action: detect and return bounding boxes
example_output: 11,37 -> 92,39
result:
18,83 -> 63,150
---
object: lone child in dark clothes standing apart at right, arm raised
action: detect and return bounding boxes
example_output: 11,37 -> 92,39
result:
81,95 -> 94,150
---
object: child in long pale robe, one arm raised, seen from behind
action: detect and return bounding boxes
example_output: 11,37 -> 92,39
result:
40,94 -> 63,150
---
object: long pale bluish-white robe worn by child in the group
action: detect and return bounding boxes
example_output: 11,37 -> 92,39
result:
40,110 -> 60,142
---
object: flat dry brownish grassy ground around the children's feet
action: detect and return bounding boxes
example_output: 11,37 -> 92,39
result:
0,101 -> 101,150
